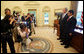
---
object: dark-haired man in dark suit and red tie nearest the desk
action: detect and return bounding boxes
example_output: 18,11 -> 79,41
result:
64,10 -> 77,48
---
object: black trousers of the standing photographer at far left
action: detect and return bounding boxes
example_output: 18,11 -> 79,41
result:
1,35 -> 15,53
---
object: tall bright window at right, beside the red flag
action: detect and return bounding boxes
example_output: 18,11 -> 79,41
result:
76,1 -> 83,26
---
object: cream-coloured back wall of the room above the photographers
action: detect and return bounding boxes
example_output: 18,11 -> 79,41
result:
1,1 -> 71,26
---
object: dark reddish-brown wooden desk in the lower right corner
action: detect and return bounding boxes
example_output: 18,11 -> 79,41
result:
71,28 -> 83,52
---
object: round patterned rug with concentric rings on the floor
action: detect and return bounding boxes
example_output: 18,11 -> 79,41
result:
22,37 -> 52,53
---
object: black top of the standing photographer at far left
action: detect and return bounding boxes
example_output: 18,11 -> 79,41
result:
1,15 -> 14,33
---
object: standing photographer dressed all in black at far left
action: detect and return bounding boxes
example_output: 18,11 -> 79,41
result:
1,8 -> 15,53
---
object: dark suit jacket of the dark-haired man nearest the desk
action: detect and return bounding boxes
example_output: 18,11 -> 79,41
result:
64,17 -> 77,33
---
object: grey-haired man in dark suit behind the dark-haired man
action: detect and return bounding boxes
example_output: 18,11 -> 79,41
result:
58,8 -> 68,42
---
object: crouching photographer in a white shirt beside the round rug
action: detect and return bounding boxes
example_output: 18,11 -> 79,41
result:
17,24 -> 31,52
